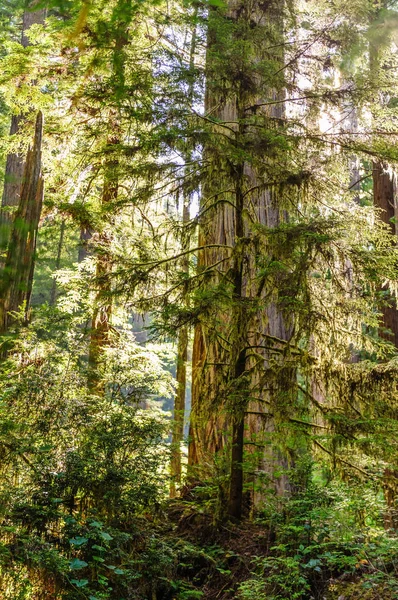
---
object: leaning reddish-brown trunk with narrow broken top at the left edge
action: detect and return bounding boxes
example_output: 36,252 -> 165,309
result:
0,112 -> 43,332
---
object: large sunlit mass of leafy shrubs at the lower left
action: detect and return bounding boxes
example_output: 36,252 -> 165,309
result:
0,294 -> 175,599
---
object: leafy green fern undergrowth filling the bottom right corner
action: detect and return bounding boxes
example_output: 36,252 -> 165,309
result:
238,474 -> 398,600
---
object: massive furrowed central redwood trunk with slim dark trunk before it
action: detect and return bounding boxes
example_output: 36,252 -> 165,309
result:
189,0 -> 295,518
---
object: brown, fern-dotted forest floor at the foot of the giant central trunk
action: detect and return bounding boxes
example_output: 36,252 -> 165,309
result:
157,500 -> 398,600
